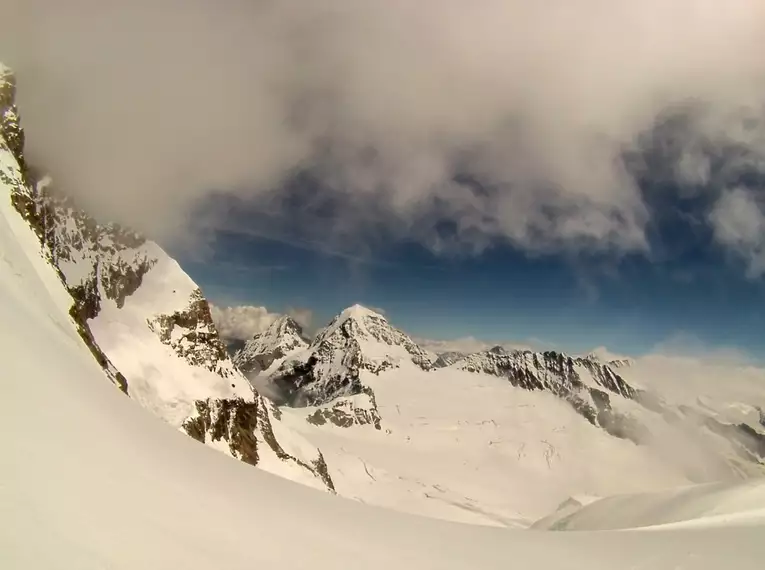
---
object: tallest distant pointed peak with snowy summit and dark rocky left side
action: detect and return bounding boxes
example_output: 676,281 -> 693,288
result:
271,305 -> 431,405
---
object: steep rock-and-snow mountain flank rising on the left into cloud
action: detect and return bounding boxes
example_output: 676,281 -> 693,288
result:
0,62 -> 332,489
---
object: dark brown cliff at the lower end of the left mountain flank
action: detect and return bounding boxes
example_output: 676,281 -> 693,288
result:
183,397 -> 335,492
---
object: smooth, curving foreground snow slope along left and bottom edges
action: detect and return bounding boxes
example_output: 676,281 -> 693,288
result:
0,173 -> 765,570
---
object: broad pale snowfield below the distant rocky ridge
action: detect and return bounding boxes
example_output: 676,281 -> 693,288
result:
282,365 -> 691,527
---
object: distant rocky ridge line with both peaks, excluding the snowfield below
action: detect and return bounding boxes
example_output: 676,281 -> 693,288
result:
260,305 -> 765,464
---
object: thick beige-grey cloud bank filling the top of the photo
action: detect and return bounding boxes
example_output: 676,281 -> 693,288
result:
0,0 -> 765,266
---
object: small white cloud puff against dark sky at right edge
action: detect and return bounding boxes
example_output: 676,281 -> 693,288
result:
710,188 -> 765,277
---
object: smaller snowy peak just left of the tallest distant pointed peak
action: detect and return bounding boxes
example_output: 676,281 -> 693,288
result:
232,315 -> 308,375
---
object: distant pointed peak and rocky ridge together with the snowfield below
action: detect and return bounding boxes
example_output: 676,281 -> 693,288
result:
236,298 -> 765,526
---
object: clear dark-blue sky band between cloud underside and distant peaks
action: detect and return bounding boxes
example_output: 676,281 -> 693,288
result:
176,215 -> 765,357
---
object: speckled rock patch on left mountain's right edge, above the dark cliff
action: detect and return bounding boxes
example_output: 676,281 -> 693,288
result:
149,289 -> 233,378
